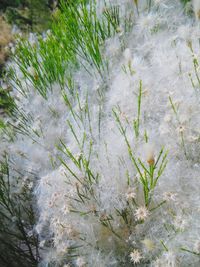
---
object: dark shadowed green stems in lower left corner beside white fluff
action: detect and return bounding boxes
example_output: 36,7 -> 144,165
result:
0,155 -> 39,267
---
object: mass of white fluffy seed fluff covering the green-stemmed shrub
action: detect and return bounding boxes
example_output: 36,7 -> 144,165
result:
0,0 -> 200,267
